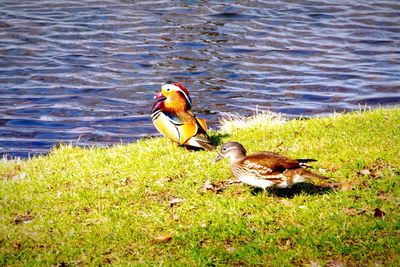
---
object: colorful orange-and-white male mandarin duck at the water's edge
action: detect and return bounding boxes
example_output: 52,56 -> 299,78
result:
151,82 -> 215,151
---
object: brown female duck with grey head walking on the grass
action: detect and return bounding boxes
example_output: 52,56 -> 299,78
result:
215,142 -> 328,189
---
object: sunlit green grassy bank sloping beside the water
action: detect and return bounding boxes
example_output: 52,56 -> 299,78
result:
0,108 -> 400,266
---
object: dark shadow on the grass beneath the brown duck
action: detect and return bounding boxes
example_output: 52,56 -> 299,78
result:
251,183 -> 333,198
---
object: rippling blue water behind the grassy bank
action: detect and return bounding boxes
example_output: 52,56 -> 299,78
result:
0,0 -> 400,157
